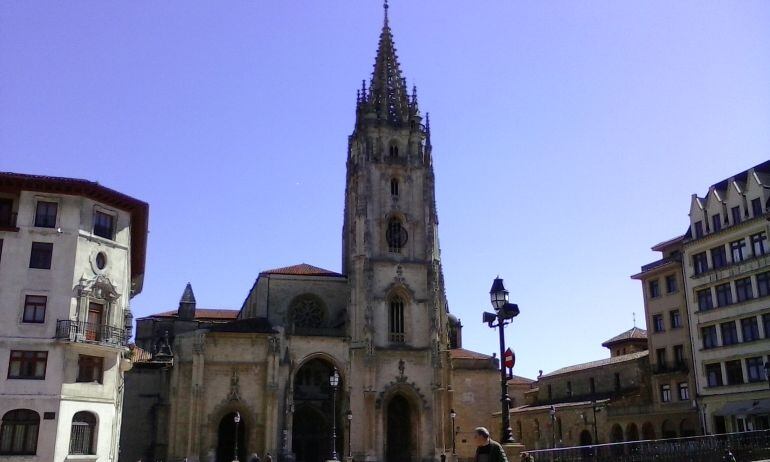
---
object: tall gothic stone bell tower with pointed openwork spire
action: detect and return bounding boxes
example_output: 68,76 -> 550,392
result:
342,3 -> 451,462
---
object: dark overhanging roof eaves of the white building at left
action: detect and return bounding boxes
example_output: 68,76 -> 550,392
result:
0,172 -> 150,295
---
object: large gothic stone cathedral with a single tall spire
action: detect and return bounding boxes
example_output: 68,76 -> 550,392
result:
120,3 -> 499,462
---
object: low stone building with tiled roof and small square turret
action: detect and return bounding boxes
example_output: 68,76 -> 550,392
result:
508,327 -> 697,449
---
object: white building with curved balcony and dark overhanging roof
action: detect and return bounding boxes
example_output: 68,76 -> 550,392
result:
0,173 -> 148,462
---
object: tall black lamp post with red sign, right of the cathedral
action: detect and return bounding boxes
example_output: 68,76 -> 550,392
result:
483,277 -> 519,444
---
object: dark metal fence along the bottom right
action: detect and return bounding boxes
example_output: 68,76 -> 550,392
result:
524,430 -> 770,462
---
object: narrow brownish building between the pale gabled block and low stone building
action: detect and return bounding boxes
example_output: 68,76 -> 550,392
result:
631,236 -> 702,436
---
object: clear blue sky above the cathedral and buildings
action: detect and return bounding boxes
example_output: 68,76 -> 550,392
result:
0,0 -> 770,377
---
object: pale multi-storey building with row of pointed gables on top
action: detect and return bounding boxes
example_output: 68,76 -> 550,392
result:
682,161 -> 770,433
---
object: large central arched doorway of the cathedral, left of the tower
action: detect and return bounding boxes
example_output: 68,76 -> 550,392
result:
291,359 -> 345,462
